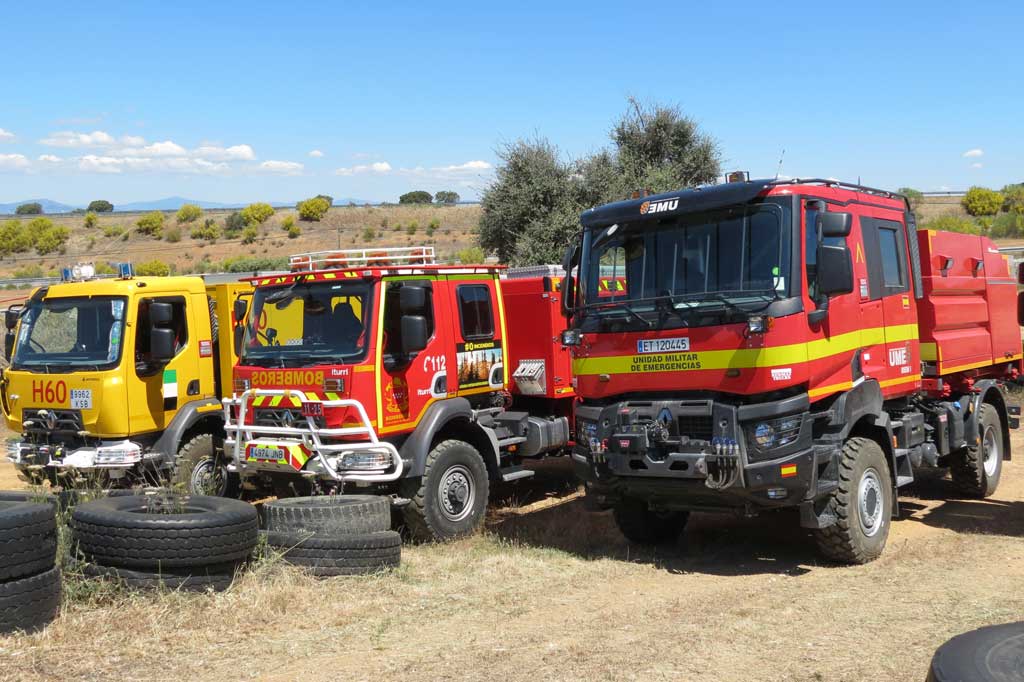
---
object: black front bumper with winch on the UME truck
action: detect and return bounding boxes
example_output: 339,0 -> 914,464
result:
572,394 -> 818,509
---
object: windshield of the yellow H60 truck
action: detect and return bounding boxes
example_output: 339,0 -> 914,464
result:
11,296 -> 125,372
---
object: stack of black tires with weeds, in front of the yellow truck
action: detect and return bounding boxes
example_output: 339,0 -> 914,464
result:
71,493 -> 259,591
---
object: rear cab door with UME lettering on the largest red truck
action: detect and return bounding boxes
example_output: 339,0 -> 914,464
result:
860,216 -> 921,394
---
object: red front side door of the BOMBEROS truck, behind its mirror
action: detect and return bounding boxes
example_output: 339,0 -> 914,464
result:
377,278 -> 454,433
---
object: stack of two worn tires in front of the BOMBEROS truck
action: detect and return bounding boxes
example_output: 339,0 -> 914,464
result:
263,495 -> 401,577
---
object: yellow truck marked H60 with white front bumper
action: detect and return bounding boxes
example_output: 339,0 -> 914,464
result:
0,264 -> 249,493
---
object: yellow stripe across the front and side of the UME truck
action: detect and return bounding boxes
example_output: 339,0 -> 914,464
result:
572,325 -> 918,376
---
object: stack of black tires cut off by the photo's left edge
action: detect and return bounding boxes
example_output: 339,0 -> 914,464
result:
0,493 -> 60,633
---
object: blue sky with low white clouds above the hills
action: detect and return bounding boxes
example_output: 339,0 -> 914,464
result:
0,0 -> 1024,204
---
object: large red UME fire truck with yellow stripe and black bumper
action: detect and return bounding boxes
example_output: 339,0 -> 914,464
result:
563,179 -> 1022,563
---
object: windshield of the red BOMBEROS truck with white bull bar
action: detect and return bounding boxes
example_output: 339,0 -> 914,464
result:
241,282 -> 370,367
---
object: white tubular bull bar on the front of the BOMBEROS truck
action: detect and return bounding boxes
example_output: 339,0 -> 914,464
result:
223,388 -> 404,483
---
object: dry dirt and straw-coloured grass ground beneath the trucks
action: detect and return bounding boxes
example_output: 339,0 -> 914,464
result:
0,433 -> 1024,682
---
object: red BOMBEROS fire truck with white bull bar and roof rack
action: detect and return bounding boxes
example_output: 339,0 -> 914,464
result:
224,247 -> 574,539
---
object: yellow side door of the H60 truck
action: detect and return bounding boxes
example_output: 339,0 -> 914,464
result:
126,294 -> 200,434
